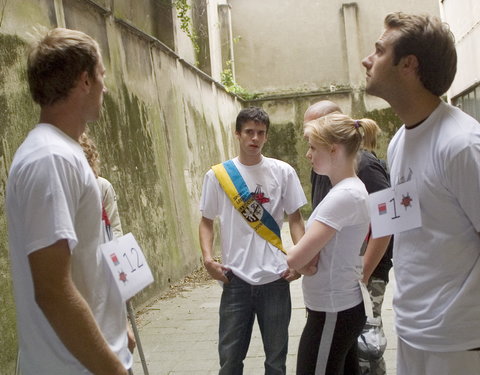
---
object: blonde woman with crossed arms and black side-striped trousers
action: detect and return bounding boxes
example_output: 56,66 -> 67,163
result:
287,114 -> 373,375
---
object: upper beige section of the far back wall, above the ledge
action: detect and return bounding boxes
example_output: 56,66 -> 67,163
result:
231,0 -> 440,113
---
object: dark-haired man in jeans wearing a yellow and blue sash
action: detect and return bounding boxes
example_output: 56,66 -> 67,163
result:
199,107 -> 306,375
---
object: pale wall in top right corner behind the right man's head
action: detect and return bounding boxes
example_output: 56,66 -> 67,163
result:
441,0 -> 480,101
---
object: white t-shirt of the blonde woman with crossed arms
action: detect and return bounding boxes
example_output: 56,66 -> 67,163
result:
302,177 -> 370,312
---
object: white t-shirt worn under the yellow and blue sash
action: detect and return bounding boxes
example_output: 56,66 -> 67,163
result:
200,157 -> 307,285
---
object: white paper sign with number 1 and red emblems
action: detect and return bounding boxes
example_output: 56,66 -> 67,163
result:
369,181 -> 422,238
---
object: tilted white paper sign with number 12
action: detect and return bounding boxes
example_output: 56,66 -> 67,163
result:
100,233 -> 153,301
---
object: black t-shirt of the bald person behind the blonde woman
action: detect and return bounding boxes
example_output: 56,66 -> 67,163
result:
310,150 -> 393,282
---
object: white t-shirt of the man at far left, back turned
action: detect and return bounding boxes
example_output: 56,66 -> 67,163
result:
6,124 -> 132,375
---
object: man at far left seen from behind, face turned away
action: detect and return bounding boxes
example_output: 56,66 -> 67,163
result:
6,28 -> 132,375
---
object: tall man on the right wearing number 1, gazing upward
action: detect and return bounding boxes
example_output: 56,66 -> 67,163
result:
363,13 -> 480,375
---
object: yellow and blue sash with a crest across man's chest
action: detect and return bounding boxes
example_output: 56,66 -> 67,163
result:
212,160 -> 287,254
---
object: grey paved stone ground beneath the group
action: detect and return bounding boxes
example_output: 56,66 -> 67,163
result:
129,228 -> 396,375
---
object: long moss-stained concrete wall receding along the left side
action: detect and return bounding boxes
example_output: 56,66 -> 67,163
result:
0,0 -> 242,374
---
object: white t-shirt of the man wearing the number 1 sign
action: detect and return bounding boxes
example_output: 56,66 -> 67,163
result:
388,102 -> 480,352
